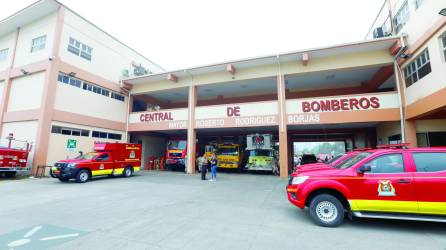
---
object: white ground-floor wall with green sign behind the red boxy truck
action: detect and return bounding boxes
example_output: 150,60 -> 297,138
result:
46,122 -> 126,165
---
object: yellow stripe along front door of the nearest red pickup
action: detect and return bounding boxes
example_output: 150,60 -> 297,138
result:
348,200 -> 419,213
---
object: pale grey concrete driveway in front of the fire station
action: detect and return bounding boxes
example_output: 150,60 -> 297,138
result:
0,172 -> 446,250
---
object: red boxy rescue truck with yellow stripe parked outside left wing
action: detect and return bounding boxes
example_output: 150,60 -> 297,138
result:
50,142 -> 142,183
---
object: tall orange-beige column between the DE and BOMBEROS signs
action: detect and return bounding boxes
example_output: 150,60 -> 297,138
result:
277,75 -> 289,178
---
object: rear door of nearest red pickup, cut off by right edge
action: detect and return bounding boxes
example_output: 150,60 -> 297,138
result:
412,152 -> 446,215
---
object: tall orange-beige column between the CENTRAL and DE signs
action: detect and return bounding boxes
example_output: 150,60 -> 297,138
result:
186,86 -> 197,174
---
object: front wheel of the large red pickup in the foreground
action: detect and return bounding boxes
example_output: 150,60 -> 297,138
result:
310,194 -> 345,227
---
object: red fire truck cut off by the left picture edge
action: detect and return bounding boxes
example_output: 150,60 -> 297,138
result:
0,134 -> 31,177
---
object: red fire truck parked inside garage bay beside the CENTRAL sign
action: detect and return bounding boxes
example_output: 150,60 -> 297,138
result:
166,139 -> 187,170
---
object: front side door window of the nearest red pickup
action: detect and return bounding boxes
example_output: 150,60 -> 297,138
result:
367,154 -> 404,174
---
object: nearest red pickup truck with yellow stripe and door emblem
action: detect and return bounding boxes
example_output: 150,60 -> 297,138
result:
286,145 -> 446,227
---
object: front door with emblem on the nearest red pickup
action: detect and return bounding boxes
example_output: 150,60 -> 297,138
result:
351,153 -> 418,213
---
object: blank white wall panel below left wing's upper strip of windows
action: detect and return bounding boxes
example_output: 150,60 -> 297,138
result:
54,82 -> 128,122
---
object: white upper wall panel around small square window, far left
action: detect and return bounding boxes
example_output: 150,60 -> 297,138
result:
14,12 -> 57,67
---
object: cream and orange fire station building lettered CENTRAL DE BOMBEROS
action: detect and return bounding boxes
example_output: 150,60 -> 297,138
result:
0,0 -> 446,177
